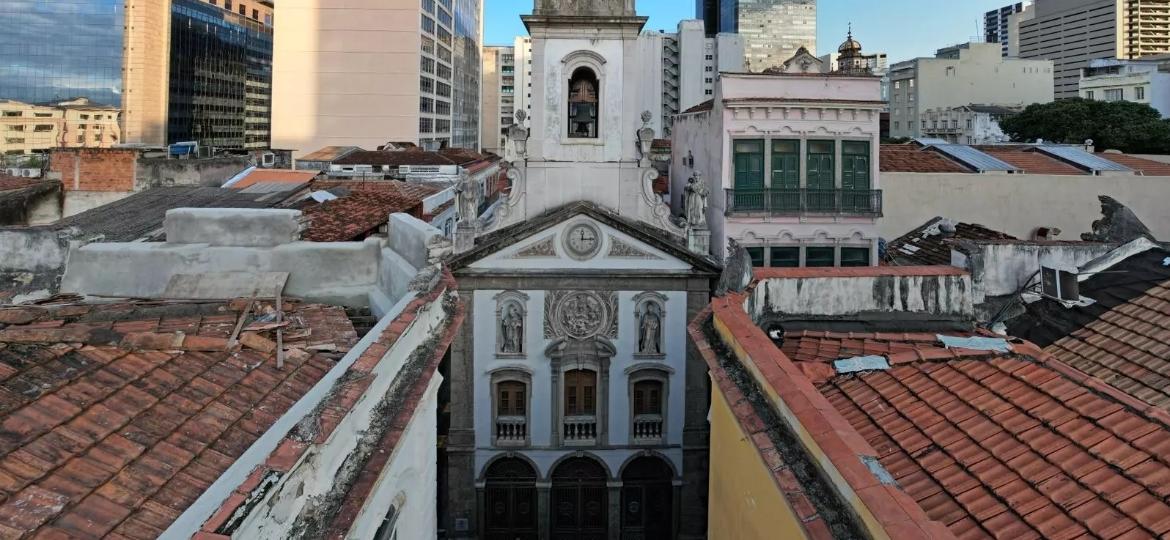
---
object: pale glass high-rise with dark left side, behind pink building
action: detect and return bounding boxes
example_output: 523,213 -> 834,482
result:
695,0 -> 817,71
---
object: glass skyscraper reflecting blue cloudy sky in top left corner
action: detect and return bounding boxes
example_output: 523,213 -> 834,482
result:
0,0 -> 125,106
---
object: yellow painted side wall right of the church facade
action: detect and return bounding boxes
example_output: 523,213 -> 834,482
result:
707,381 -> 805,540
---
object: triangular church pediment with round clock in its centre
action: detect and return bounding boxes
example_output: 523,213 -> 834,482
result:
452,203 -> 718,272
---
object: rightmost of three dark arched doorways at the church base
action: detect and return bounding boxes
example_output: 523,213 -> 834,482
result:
621,456 -> 674,540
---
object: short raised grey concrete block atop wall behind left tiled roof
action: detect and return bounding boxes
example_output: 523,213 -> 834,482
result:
163,208 -> 301,248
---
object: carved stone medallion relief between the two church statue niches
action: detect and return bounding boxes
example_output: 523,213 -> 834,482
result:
544,291 -> 618,339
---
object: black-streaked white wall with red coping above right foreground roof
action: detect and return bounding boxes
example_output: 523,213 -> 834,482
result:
750,275 -> 975,320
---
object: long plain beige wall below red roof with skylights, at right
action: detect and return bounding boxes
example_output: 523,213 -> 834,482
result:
879,173 -> 1170,240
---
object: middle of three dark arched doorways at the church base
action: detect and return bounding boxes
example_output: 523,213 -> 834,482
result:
552,457 -> 608,540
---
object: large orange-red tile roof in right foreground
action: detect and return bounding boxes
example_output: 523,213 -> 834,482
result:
783,332 -> 1170,539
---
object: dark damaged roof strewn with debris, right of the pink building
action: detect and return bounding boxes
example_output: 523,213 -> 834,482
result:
886,217 -> 1017,265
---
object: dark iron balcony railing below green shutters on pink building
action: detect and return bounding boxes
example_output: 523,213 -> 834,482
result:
727,189 -> 882,217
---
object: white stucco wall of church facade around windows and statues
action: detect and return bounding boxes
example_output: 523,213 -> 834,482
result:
473,290 -> 687,475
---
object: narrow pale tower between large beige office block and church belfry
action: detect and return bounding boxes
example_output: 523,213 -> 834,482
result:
480,46 -> 516,155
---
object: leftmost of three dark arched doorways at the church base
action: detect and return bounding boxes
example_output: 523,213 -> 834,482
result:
483,458 -> 538,540
